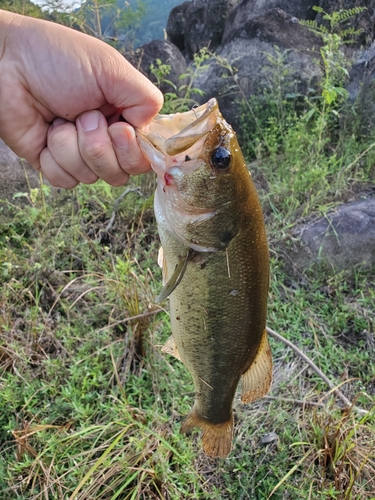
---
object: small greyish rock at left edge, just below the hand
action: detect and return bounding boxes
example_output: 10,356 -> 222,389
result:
0,139 -> 43,202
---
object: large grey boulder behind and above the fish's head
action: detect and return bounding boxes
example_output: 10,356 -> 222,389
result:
193,8 -> 321,132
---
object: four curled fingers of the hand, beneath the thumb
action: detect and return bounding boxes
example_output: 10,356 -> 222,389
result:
40,111 -> 150,189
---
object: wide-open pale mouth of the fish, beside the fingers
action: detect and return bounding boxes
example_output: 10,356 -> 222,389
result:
136,98 -> 220,174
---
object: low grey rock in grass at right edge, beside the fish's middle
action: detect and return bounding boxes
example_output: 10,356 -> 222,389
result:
289,197 -> 375,270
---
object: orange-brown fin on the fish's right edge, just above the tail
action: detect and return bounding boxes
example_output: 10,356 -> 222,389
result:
241,330 -> 272,403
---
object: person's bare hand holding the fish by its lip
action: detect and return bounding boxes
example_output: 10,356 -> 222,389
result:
0,10 -> 163,188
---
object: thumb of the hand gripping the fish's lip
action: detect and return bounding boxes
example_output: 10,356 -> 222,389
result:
97,46 -> 163,127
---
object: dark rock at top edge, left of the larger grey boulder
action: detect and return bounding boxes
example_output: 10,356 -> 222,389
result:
167,0 -> 238,59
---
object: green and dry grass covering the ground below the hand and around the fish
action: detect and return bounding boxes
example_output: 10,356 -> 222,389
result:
0,163 -> 375,500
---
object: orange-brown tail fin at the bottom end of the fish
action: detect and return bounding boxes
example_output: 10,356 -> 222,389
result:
181,407 -> 233,458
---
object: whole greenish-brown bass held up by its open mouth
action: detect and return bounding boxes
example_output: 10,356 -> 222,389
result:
136,98 -> 272,458
